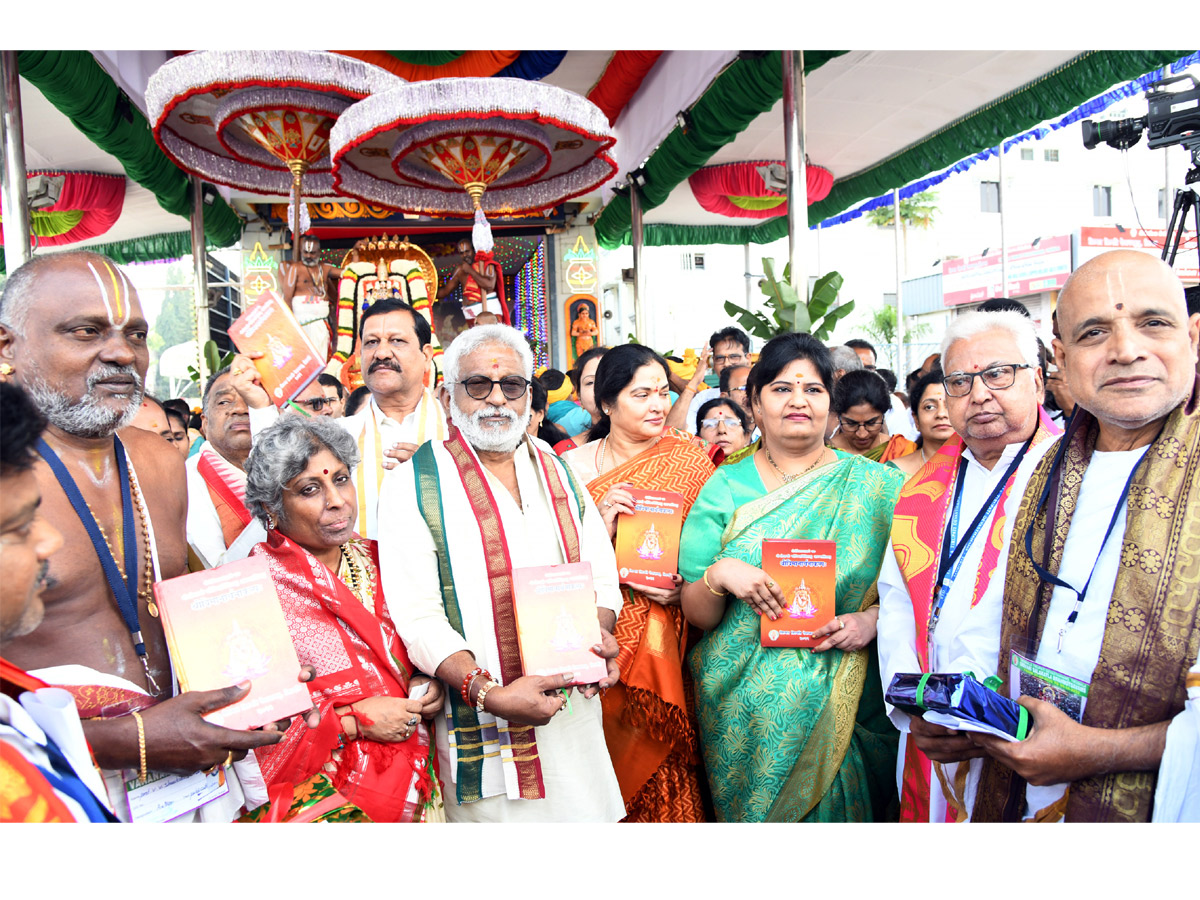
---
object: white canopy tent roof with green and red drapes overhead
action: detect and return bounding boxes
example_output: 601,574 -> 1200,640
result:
7,50 -> 1187,268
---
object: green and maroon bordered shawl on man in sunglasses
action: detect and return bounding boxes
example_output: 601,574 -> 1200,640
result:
413,427 -> 583,803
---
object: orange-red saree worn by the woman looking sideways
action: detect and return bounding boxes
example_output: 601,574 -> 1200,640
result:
588,428 -> 720,822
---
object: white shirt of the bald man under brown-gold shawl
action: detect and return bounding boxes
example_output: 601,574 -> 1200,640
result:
1010,445 -> 1150,818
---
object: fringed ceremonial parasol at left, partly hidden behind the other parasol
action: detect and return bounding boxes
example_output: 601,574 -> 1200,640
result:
146,50 -> 403,243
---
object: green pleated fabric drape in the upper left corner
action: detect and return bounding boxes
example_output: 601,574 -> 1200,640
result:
17,50 -> 241,247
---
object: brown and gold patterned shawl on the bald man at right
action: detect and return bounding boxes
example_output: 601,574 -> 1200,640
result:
971,378 -> 1200,822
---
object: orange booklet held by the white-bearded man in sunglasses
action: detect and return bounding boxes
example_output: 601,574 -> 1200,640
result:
512,563 -> 608,684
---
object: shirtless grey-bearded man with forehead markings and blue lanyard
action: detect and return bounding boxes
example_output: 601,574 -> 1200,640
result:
0,251 -> 280,822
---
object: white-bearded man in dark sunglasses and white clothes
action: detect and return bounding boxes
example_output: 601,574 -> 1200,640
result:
379,325 -> 625,822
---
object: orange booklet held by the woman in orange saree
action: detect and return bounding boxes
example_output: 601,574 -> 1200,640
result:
617,487 -> 684,588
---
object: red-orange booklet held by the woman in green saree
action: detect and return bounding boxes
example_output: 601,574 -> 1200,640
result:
758,539 -> 838,647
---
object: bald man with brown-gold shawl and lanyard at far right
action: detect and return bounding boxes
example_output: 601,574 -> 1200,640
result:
971,251 -> 1200,822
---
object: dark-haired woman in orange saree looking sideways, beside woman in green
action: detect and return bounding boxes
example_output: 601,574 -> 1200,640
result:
563,344 -> 722,822
